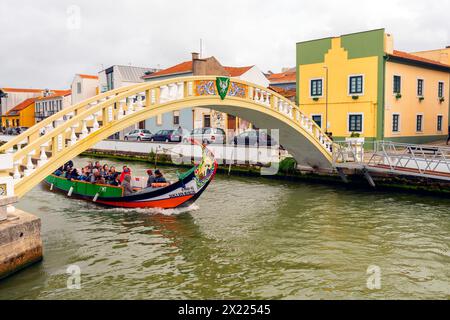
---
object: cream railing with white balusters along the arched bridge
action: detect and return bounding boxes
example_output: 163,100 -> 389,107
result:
2,77 -> 332,196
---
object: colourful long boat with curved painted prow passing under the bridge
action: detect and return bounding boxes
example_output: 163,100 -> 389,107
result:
44,146 -> 217,209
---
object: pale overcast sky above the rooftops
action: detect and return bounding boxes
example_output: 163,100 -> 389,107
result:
0,0 -> 450,89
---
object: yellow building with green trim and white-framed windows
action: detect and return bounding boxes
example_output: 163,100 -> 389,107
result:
297,29 -> 450,143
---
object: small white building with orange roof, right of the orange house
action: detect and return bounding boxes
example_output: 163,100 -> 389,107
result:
34,90 -> 72,123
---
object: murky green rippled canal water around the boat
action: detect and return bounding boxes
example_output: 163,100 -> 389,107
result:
0,158 -> 450,299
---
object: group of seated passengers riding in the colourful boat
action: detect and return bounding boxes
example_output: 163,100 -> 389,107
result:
53,160 -> 168,195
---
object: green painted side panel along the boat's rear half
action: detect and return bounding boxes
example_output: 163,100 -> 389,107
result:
45,174 -> 123,197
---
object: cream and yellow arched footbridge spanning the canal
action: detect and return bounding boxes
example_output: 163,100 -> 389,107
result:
0,76 -> 332,197
